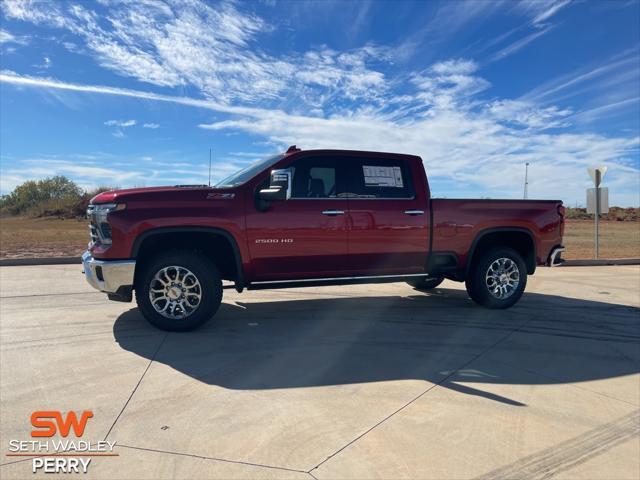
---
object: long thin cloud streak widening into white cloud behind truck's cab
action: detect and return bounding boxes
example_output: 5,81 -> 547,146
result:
0,64 -> 640,203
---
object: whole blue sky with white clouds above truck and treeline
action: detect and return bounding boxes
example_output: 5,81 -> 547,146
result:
0,0 -> 640,206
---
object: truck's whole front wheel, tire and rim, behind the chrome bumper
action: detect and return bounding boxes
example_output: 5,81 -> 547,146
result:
135,250 -> 222,332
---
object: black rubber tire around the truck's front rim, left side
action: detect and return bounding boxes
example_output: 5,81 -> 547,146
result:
135,250 -> 222,332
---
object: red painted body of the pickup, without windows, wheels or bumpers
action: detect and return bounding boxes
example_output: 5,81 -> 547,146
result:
90,150 -> 563,282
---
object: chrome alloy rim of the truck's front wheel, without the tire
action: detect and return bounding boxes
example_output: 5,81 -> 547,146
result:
149,265 -> 202,320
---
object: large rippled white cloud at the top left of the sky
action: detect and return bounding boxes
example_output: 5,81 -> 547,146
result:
3,1 -> 388,106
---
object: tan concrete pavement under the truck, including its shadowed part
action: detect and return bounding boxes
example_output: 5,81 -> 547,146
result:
0,265 -> 640,479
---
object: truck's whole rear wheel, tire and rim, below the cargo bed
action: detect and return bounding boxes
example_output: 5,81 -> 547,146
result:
465,247 -> 527,309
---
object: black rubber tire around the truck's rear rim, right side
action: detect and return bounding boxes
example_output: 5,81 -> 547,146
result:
465,247 -> 527,309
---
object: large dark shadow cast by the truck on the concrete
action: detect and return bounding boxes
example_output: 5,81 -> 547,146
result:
113,288 -> 640,406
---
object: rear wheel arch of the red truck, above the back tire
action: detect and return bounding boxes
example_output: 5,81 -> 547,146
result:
465,227 -> 537,278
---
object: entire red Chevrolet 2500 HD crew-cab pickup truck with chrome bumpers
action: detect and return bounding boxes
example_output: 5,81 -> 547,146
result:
82,146 -> 565,330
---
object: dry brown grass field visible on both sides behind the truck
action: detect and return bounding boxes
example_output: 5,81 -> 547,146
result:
0,217 -> 640,260
